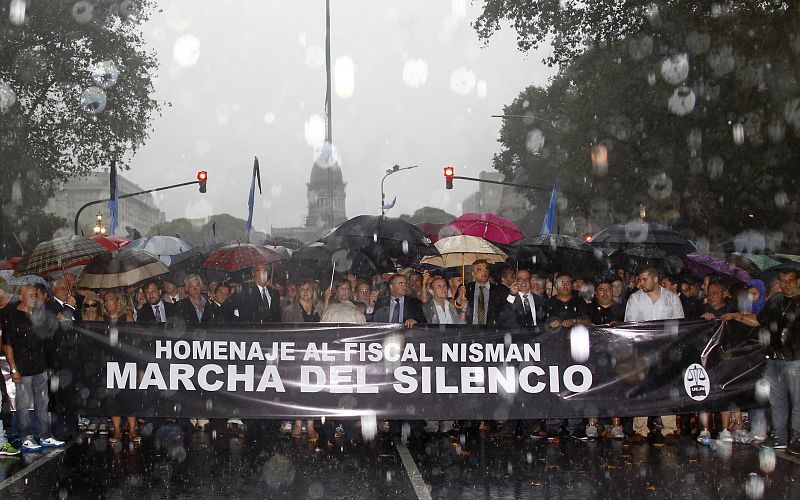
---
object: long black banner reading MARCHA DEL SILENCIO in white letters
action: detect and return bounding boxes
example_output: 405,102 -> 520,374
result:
51,320 -> 765,420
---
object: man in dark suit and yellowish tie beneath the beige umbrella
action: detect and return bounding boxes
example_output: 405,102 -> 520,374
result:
467,259 -> 514,326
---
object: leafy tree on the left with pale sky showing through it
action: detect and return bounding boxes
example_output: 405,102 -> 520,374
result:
0,0 -> 161,253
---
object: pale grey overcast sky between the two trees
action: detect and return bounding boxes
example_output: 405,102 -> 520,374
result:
126,0 -> 554,232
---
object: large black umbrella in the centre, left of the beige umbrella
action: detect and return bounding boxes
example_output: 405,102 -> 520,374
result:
319,215 -> 438,264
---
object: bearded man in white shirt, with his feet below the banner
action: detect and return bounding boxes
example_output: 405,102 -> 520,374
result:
625,267 -> 683,442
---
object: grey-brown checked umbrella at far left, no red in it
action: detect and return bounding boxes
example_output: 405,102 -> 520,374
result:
14,236 -> 106,276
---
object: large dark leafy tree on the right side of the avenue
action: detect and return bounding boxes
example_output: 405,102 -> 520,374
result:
484,2 -> 800,248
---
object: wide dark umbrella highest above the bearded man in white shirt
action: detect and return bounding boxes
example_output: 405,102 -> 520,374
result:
592,220 -> 697,255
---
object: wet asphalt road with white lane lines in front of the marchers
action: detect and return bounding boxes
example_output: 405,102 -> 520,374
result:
0,426 -> 800,499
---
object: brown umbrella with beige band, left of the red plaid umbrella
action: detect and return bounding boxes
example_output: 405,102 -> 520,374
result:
75,248 -> 169,290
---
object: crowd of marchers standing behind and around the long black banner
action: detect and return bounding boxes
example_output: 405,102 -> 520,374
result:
0,260 -> 800,456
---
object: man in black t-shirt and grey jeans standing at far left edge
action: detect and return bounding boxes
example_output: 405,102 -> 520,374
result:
2,285 -> 64,451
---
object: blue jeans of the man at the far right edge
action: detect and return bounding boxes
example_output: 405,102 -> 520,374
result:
764,359 -> 800,443
